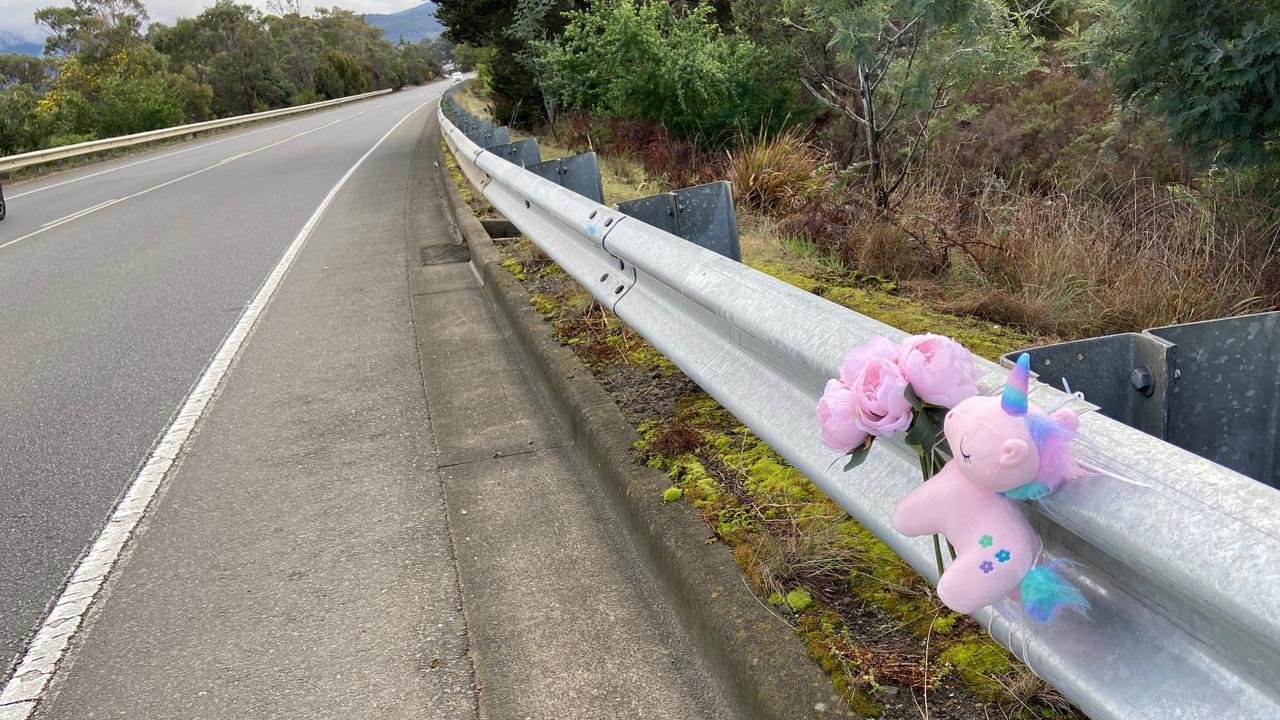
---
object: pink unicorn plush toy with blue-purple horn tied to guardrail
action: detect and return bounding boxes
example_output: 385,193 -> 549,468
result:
893,354 -> 1088,623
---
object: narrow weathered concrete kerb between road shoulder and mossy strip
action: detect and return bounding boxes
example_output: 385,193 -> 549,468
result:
435,126 -> 856,720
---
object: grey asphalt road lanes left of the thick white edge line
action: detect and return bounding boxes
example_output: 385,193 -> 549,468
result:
0,83 -> 445,676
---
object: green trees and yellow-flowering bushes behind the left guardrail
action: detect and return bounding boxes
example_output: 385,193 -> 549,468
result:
0,0 -> 451,156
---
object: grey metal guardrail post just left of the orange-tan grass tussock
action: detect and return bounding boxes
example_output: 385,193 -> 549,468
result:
618,181 -> 742,263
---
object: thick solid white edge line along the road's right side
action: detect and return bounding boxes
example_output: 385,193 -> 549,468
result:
0,99 -> 434,720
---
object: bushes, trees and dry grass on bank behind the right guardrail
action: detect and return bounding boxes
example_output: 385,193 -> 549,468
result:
440,0 -> 1280,338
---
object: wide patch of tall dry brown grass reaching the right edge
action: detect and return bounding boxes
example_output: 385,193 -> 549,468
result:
906,167 -> 1280,336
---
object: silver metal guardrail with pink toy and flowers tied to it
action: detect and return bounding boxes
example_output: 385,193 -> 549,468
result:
439,92 -> 1280,720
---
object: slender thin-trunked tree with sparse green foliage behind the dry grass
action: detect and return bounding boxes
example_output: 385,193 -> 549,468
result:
783,0 -> 1036,208
